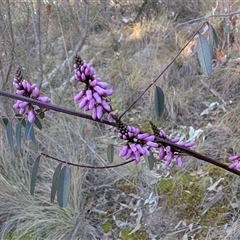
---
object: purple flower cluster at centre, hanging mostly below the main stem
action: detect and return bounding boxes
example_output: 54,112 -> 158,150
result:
118,122 -> 158,164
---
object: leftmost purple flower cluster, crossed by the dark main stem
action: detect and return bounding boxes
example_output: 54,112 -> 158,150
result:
13,68 -> 51,123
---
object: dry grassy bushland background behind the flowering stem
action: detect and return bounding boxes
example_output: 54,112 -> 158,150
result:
0,0 -> 240,240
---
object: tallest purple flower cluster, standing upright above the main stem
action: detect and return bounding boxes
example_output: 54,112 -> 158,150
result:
74,56 -> 113,122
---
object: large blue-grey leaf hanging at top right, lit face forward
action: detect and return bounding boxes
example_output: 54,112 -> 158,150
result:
197,34 -> 212,76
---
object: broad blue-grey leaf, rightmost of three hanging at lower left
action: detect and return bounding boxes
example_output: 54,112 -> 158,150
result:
57,165 -> 71,208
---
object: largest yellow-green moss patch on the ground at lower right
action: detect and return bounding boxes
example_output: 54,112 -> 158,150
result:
157,164 -> 230,225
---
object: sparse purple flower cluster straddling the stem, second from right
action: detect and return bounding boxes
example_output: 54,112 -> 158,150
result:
157,130 -> 194,167
